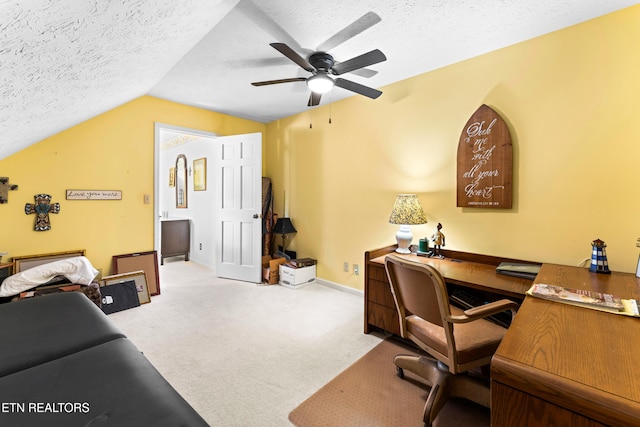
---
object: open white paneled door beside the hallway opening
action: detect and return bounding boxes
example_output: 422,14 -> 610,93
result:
214,133 -> 262,283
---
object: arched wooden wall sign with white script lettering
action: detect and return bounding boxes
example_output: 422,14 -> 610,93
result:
457,104 -> 513,209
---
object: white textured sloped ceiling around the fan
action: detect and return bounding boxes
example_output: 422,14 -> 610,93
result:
0,0 -> 637,159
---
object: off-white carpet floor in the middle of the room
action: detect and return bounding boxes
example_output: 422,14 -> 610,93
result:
109,258 -> 384,427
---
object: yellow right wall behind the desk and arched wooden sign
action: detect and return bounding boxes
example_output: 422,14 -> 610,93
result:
266,6 -> 640,288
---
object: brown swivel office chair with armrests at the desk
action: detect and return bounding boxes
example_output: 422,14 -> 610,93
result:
385,255 -> 518,427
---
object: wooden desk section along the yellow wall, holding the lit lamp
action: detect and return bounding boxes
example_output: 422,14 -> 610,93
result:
364,245 -> 532,335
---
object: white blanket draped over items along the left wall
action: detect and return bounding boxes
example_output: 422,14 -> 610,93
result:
0,256 -> 98,297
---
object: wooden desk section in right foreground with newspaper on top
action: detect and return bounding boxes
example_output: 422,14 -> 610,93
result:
491,264 -> 640,427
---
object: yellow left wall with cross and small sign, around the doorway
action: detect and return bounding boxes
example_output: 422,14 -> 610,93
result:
0,96 -> 265,274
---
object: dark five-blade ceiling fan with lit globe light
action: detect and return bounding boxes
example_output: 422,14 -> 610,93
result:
251,43 -> 387,107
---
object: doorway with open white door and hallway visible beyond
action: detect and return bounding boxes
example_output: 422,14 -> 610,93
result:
154,123 -> 262,283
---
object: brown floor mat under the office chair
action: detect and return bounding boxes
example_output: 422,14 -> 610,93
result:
289,338 -> 490,427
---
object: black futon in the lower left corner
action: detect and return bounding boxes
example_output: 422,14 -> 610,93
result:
0,292 -> 207,427
